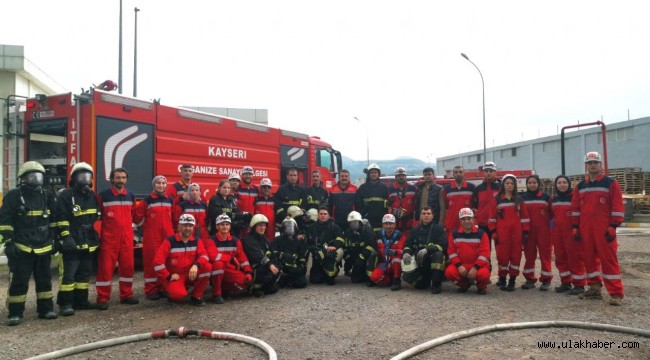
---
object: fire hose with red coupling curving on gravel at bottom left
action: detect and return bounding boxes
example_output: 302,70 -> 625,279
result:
27,327 -> 278,360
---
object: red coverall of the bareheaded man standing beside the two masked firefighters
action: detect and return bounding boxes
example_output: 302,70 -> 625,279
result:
95,186 -> 135,302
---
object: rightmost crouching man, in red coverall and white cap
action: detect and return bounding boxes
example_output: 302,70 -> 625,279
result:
445,208 -> 490,295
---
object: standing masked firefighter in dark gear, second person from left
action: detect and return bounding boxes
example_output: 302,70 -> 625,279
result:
55,162 -> 99,316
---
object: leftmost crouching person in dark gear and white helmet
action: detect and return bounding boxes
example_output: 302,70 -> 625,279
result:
242,214 -> 280,297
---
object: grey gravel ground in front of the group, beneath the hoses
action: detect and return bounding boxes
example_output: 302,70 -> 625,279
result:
0,229 -> 650,359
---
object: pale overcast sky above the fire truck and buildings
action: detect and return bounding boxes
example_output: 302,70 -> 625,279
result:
0,0 -> 650,161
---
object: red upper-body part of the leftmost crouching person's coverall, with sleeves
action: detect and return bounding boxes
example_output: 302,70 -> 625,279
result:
153,234 -> 208,280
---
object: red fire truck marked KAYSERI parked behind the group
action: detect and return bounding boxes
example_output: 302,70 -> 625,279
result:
18,89 -> 342,198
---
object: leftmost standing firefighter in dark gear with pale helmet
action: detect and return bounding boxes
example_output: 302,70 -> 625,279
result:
0,161 -> 58,326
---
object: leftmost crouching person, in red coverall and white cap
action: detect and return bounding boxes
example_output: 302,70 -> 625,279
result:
154,214 -> 210,306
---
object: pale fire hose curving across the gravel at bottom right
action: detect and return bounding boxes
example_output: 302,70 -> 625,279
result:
391,321 -> 650,360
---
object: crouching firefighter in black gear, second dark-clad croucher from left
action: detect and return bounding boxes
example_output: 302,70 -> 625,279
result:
271,217 -> 309,289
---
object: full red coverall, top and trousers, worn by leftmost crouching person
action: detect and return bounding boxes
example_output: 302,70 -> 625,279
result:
154,234 -> 210,301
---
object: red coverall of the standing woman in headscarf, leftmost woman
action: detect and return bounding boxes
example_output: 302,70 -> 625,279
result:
133,192 -> 174,295
